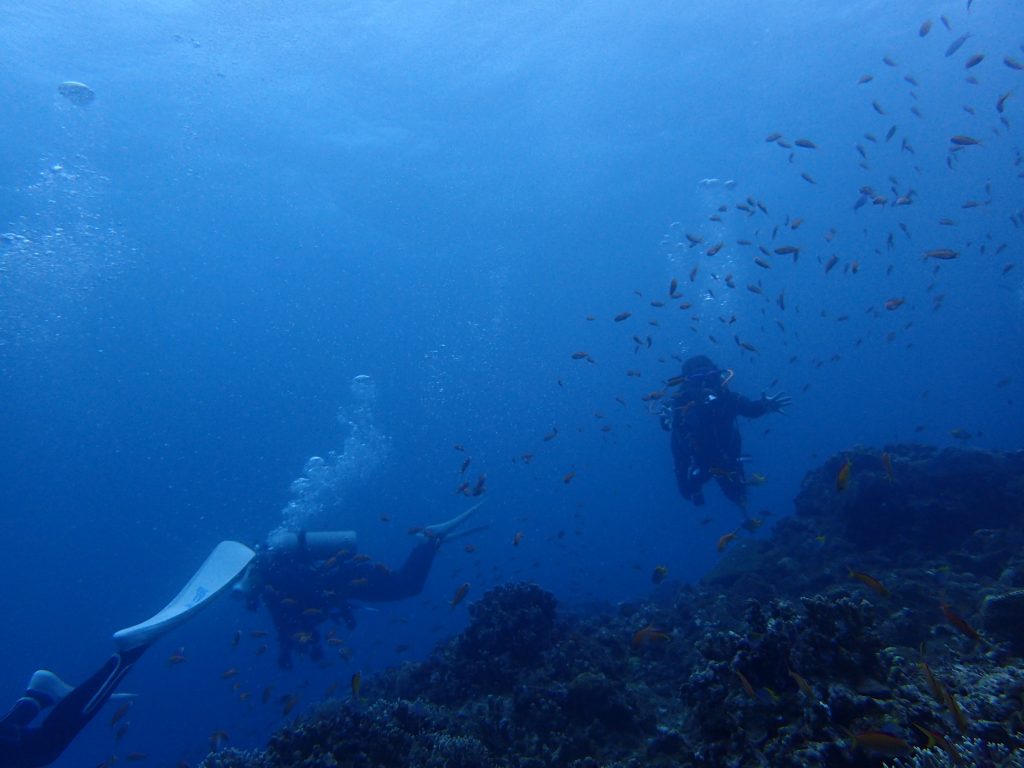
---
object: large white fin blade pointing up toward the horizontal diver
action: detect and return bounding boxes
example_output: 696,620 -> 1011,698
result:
114,542 -> 256,652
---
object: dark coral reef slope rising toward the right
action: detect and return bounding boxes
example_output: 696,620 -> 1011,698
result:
199,445 -> 1024,768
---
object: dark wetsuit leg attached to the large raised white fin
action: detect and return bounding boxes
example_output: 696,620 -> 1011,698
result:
24,645 -> 148,766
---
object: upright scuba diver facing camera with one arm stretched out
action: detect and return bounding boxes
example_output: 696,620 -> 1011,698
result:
660,354 -> 793,511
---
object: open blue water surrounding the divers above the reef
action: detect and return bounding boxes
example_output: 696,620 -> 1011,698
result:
0,0 -> 1024,766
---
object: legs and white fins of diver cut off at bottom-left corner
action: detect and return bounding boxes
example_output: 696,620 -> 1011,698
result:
0,542 -> 256,768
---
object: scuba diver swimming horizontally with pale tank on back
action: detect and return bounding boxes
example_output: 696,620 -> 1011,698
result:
234,502 -> 484,669
